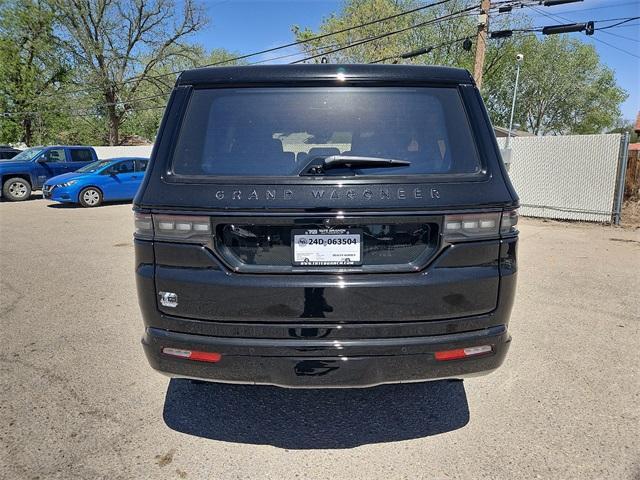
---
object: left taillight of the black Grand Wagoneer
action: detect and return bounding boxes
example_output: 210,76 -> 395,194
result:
135,213 -> 211,243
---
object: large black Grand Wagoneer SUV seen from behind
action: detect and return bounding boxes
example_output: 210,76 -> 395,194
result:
134,64 -> 518,387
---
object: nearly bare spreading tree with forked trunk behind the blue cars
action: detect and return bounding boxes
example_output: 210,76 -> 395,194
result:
51,0 -> 207,145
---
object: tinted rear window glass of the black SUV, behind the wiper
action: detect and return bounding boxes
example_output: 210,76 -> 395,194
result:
173,87 -> 481,176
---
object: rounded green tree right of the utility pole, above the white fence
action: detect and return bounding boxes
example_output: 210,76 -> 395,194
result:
483,35 -> 626,135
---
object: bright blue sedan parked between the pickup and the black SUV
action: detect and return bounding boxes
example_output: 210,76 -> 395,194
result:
42,157 -> 149,207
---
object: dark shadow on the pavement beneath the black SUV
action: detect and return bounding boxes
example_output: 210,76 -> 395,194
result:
163,379 -> 469,449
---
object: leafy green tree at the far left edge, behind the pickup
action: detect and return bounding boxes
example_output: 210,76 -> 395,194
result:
0,0 -> 70,145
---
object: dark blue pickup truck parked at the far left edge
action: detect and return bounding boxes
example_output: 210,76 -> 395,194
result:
0,145 -> 98,202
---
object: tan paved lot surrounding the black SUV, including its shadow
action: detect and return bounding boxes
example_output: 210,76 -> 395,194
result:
0,200 -> 640,480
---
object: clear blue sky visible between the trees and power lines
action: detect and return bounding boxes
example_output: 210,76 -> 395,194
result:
195,0 -> 640,120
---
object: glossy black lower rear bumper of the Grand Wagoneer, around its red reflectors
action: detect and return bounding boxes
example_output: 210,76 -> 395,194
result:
142,325 -> 511,388
